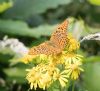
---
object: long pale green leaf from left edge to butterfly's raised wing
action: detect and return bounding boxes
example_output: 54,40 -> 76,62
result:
0,20 -> 56,38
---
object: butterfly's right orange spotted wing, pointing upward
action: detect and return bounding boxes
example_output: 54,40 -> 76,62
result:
50,20 -> 68,50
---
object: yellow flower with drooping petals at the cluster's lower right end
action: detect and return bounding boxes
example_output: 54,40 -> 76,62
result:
66,61 -> 84,80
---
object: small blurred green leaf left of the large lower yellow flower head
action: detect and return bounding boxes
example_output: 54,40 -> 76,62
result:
4,67 -> 26,83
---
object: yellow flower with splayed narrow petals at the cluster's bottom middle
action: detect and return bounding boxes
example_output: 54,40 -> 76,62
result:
53,68 -> 69,87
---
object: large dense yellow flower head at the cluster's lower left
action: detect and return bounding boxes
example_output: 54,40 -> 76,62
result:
26,64 -> 52,89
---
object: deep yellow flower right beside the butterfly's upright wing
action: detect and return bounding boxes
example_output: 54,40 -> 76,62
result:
65,34 -> 80,52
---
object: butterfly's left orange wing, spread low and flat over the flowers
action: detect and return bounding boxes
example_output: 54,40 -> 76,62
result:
28,41 -> 61,55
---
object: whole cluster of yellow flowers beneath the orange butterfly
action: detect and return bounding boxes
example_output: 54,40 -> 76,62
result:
23,34 -> 83,89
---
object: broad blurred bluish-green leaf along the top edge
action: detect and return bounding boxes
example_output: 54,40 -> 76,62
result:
4,0 -> 72,18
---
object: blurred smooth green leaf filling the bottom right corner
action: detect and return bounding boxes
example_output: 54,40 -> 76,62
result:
83,59 -> 100,91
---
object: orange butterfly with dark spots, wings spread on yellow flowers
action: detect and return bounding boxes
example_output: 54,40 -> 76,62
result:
28,19 -> 69,55
